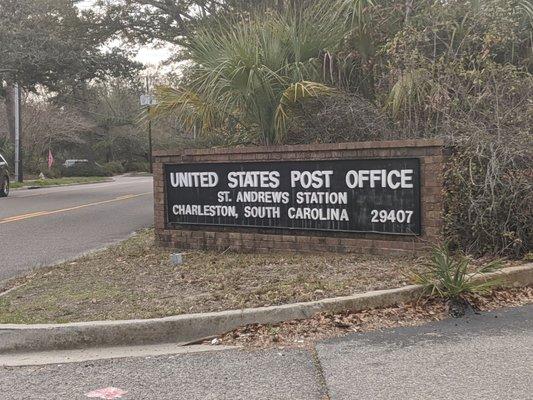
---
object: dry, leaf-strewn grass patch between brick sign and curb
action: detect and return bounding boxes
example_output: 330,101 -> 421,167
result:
0,230 -> 434,323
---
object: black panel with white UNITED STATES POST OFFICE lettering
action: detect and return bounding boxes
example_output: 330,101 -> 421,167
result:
165,158 -> 420,235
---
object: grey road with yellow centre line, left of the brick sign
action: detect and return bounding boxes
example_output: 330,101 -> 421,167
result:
0,176 -> 153,281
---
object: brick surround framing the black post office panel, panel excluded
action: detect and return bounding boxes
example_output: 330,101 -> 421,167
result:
154,140 -> 446,254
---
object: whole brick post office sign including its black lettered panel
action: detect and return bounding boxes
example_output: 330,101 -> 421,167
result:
154,140 -> 445,254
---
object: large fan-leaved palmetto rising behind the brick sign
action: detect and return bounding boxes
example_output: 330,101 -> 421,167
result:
154,2 -> 344,144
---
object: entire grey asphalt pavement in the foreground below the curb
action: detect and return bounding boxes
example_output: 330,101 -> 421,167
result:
0,305 -> 533,400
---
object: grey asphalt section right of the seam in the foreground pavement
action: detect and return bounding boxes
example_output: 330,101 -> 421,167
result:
317,305 -> 533,400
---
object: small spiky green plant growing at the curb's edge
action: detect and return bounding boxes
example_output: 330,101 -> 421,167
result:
413,244 -> 502,316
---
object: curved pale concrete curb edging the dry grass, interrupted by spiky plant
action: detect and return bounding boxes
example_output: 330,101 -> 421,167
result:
0,263 -> 533,354
